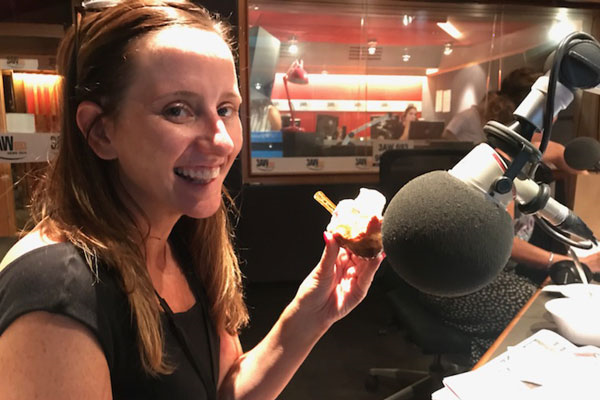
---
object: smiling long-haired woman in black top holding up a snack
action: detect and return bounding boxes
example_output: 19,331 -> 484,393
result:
0,0 -> 381,400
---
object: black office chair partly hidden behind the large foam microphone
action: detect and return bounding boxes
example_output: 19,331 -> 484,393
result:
365,147 -> 473,400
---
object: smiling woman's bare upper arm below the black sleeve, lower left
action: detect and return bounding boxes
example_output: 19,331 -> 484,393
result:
0,311 -> 112,400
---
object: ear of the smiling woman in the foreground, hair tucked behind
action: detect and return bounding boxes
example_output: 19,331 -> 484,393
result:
75,101 -> 117,160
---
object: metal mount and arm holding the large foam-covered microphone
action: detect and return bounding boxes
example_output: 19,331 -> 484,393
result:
483,32 -> 600,248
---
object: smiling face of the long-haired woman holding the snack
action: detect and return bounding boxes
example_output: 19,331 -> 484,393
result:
107,26 -> 242,221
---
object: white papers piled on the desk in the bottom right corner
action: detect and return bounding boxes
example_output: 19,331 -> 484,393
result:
431,329 -> 600,400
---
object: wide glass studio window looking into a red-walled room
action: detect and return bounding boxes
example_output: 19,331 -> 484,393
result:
245,0 -> 594,178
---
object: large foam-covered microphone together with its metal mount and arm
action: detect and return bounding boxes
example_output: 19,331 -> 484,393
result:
382,33 -> 600,297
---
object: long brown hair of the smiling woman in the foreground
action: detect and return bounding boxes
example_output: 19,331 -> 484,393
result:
32,0 -> 248,375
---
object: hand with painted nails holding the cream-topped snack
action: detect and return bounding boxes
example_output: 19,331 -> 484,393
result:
295,232 -> 384,327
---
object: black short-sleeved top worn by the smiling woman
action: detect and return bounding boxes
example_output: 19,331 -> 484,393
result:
0,243 -> 219,400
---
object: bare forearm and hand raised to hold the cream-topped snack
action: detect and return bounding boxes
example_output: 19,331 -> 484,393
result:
219,234 -> 383,400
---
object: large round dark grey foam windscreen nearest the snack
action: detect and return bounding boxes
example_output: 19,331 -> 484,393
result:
382,171 -> 513,297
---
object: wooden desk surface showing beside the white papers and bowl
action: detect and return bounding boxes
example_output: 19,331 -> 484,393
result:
473,282 -> 561,369
